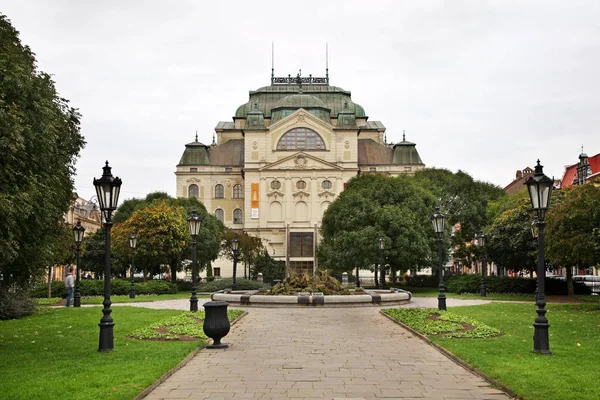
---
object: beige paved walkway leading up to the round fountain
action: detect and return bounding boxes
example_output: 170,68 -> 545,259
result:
132,298 -> 509,400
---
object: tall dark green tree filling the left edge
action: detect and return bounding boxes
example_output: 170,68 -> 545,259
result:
0,14 -> 85,287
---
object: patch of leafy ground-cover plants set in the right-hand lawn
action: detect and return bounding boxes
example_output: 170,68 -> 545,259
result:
382,308 -> 500,339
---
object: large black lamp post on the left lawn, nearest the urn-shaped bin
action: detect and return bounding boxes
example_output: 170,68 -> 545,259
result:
94,161 -> 122,351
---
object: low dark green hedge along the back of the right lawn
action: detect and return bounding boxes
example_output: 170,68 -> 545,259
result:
446,274 -> 591,295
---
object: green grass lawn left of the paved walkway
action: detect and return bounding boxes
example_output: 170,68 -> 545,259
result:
0,307 -> 240,400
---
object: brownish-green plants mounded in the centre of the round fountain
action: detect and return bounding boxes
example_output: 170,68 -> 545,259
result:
269,270 -> 350,296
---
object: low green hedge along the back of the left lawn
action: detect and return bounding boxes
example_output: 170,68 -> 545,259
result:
31,279 -> 177,298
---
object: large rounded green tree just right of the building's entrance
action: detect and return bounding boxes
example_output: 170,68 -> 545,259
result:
318,174 -> 435,276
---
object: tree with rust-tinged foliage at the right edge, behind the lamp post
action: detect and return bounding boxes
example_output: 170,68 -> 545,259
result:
545,184 -> 600,294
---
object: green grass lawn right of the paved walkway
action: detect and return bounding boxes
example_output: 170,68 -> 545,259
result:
384,303 -> 600,400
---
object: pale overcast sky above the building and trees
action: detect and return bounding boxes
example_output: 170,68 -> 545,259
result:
0,0 -> 600,203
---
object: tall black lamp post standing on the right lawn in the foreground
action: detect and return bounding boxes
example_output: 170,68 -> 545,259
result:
525,160 -> 554,354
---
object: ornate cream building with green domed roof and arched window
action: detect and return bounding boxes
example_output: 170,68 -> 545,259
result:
175,76 -> 424,276
